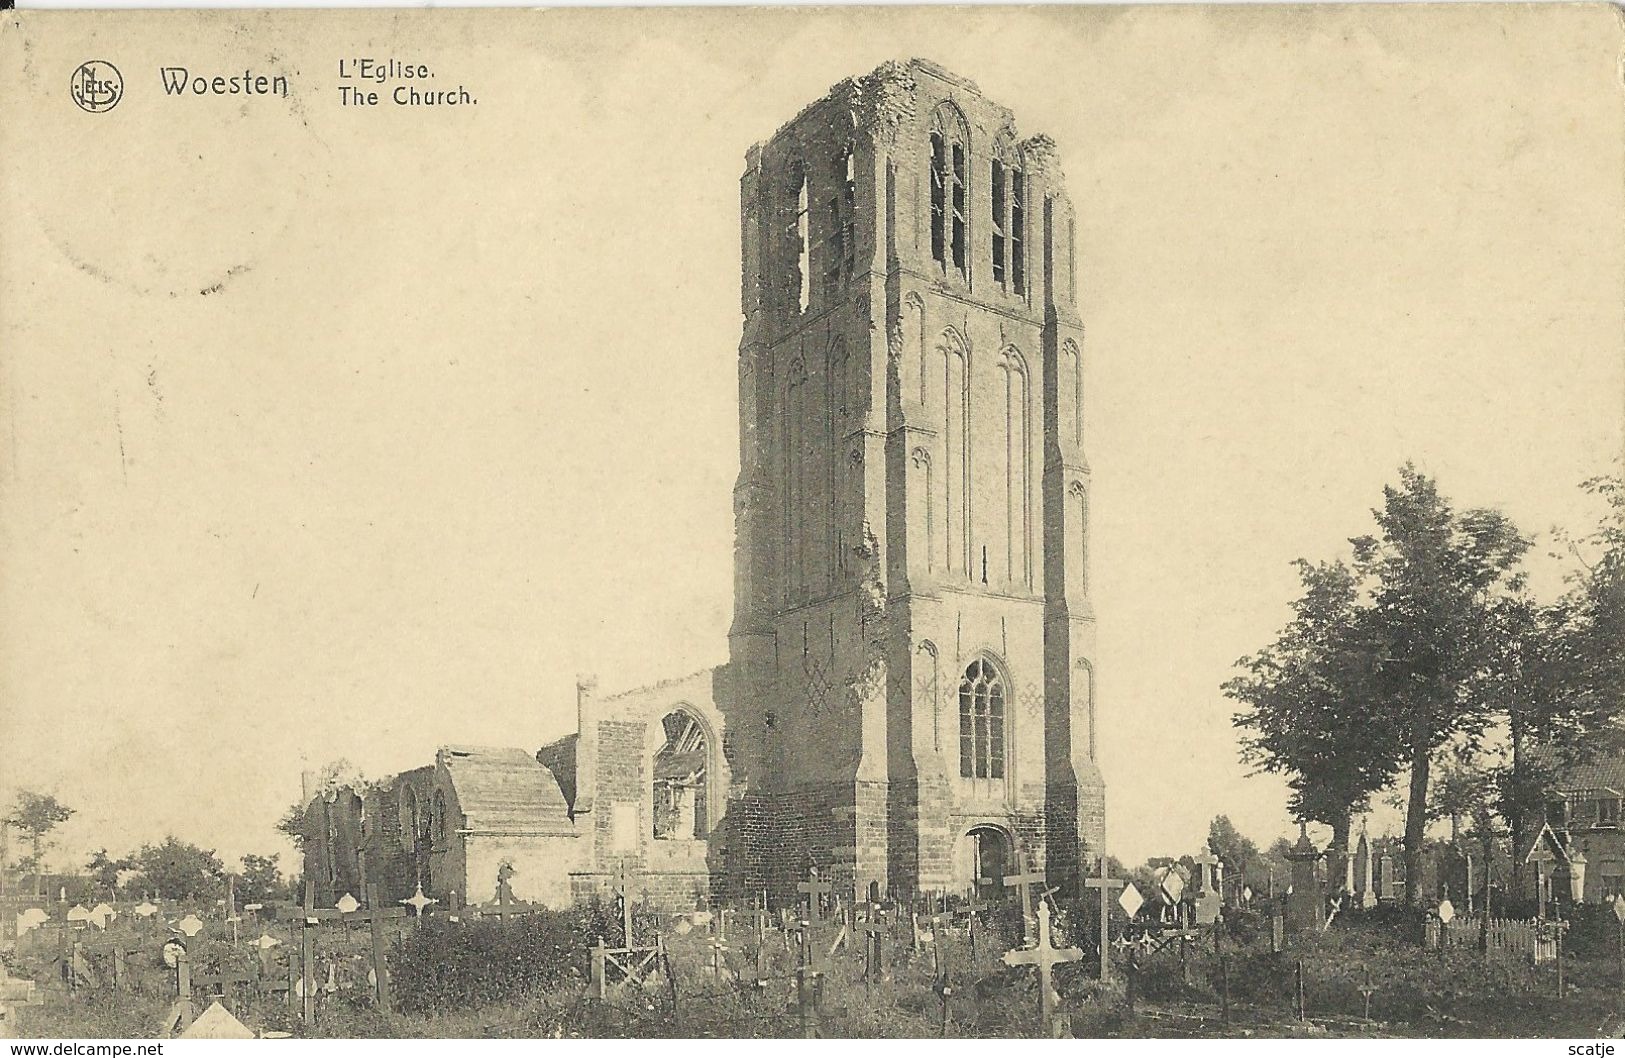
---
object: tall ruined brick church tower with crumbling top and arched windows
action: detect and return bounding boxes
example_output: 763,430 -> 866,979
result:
715,60 -> 1105,900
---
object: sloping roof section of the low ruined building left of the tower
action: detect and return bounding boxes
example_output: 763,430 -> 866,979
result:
439,746 -> 570,834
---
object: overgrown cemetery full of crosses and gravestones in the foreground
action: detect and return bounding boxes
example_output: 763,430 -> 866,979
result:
9,834 -> 1625,1038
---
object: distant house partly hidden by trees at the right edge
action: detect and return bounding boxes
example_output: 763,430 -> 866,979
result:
1518,756 -> 1625,904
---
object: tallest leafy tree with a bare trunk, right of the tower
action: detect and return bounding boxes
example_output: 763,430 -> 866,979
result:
1350,463 -> 1529,905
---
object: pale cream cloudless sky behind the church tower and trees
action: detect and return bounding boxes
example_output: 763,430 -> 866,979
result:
0,5 -> 1625,863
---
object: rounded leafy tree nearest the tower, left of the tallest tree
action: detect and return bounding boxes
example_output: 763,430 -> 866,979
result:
1224,559 -> 1401,878
